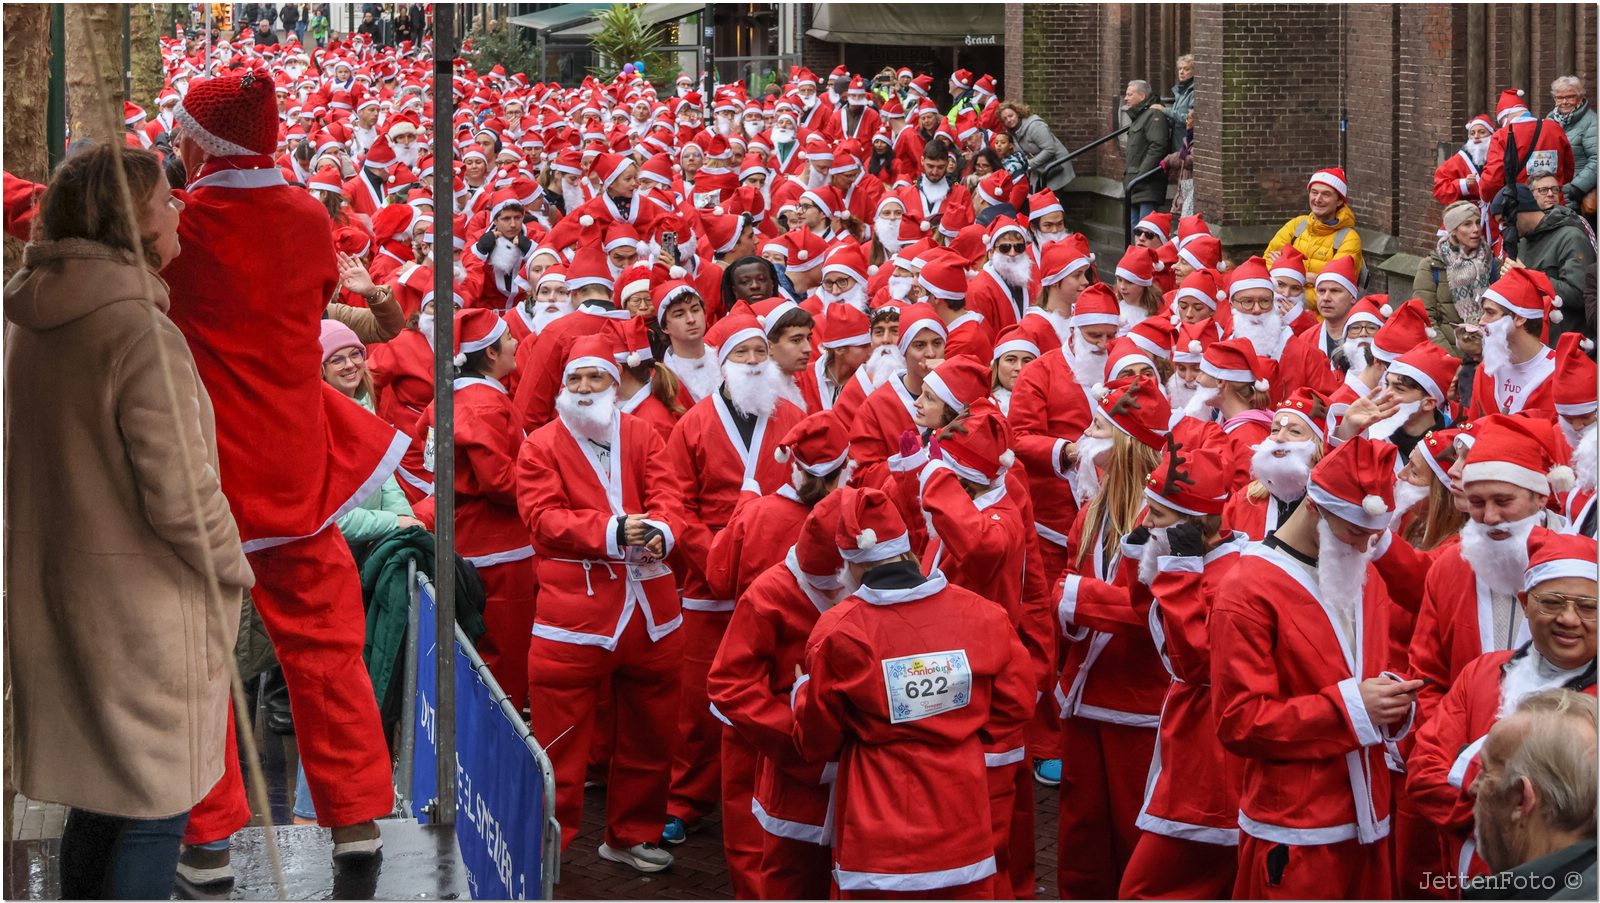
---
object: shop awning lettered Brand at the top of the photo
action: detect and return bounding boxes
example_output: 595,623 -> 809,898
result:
806,3 -> 1005,46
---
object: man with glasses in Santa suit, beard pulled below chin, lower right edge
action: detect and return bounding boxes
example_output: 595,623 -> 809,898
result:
1406,527 -> 1597,877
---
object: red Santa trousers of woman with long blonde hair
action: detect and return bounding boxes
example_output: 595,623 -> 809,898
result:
1056,717 -> 1155,900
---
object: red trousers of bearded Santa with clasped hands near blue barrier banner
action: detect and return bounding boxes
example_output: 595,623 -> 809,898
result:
528,612 -> 683,850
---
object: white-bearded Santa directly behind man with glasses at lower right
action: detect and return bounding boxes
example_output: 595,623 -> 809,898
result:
1410,415 -> 1574,724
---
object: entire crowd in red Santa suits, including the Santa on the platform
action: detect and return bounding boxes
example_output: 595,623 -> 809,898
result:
6,14 -> 1597,898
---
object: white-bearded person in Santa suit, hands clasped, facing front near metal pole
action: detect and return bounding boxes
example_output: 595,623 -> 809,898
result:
517,336 -> 683,873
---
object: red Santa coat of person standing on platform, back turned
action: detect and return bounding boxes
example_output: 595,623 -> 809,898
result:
162,157 -> 408,552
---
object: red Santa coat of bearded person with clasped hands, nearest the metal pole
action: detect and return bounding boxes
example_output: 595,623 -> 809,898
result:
517,415 -> 683,650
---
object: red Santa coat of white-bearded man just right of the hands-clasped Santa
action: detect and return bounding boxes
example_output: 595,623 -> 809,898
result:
667,391 -> 805,612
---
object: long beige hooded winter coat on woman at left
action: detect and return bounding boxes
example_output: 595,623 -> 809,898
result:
5,240 -> 253,818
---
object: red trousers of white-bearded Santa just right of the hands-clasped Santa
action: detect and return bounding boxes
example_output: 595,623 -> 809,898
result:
665,610 -> 733,825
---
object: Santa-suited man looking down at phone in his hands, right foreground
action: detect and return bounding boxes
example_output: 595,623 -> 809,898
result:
1211,439 -> 1422,900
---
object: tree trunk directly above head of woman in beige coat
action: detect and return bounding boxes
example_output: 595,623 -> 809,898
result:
67,3 -> 126,142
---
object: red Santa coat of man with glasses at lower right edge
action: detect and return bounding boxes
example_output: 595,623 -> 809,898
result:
1405,645 -> 1595,876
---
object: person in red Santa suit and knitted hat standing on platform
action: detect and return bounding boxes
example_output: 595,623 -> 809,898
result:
163,67 -> 406,884
